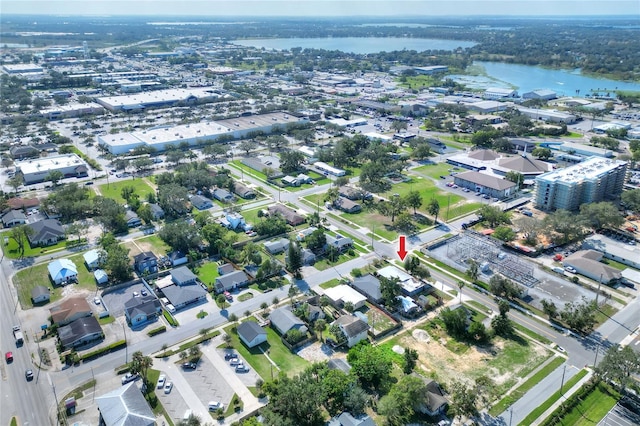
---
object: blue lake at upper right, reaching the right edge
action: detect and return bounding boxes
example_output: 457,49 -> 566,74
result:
450,61 -> 640,96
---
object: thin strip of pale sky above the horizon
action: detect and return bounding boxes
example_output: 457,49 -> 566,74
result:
2,0 -> 640,18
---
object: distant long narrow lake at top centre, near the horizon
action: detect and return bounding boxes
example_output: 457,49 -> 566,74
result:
232,37 -> 477,54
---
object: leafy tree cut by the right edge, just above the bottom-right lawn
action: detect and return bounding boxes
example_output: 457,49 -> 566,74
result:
595,344 -> 640,389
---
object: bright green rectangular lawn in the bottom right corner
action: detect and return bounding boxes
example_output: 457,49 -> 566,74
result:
559,382 -> 620,426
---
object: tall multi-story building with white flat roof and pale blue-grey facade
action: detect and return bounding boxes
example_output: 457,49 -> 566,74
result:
535,157 -> 627,211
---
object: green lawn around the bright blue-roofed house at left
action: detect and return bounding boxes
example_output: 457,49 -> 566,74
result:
13,254 -> 97,309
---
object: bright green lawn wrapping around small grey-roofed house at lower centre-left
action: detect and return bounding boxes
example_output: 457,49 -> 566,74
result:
221,320 -> 309,381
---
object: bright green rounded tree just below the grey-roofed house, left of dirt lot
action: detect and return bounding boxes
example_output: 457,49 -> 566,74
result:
347,341 -> 393,389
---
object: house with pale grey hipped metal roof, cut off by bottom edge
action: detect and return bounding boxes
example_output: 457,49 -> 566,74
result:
96,382 -> 156,426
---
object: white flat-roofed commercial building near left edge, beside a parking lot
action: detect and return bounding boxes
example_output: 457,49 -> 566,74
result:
15,154 -> 89,185
